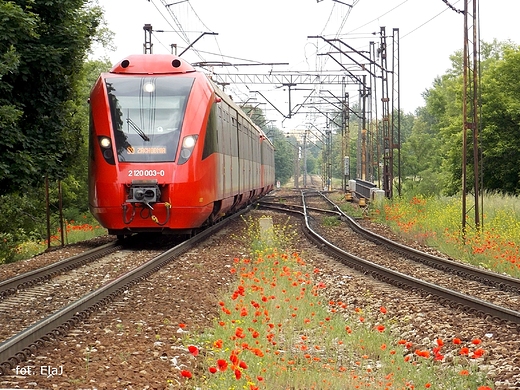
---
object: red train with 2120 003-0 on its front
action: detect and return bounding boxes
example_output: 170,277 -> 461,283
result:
89,54 -> 274,237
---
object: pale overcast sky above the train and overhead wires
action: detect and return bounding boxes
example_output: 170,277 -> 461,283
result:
93,0 -> 520,127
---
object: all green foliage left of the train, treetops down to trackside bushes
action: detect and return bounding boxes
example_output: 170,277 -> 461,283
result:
0,0 -> 114,262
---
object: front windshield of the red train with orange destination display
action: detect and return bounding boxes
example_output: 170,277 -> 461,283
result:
106,76 -> 194,162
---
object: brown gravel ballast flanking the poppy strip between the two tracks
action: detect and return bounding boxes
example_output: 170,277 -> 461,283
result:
0,200 -> 520,390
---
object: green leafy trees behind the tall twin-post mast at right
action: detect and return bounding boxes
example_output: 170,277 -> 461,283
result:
416,41 -> 520,195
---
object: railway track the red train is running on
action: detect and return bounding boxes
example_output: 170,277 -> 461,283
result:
0,209 -> 247,376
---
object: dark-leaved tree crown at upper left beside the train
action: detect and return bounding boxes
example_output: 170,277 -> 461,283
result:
0,0 -> 101,194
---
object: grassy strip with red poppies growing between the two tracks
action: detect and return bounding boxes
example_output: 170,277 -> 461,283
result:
177,216 -> 491,390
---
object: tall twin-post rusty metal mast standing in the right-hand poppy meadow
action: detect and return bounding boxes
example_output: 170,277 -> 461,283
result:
462,0 -> 480,236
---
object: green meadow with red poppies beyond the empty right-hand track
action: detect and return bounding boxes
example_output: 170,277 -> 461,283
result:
371,195 -> 520,277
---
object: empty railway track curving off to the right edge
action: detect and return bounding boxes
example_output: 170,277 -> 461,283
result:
260,191 -> 520,329
